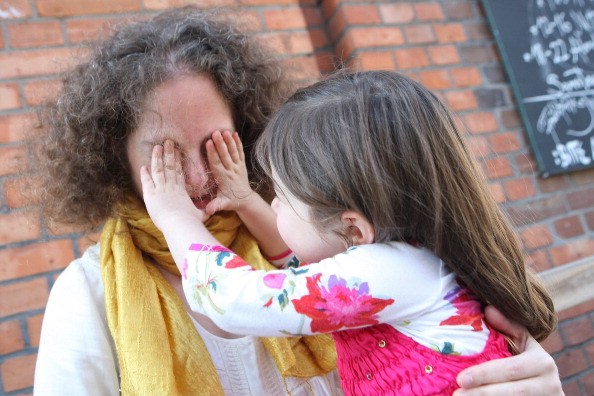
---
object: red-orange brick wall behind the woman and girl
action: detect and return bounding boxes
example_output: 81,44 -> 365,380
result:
0,0 -> 594,395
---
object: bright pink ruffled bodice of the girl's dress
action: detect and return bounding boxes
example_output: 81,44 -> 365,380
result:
334,324 -> 511,396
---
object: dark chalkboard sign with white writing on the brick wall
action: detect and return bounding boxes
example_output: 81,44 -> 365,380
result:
483,0 -> 594,177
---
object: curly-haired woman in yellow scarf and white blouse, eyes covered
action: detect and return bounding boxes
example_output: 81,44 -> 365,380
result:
35,8 -> 561,395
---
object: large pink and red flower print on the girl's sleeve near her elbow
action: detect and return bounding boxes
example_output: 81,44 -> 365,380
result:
292,274 -> 394,333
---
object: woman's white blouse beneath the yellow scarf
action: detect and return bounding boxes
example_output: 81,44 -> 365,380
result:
34,244 -> 342,396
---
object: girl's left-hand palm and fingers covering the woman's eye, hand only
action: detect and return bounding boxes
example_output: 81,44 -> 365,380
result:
140,140 -> 207,232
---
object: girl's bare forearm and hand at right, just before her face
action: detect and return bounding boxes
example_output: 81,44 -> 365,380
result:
205,131 -> 288,257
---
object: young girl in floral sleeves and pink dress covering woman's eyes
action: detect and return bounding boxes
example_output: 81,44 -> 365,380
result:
141,72 -> 555,395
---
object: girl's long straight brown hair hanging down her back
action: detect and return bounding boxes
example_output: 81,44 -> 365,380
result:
257,71 -> 556,340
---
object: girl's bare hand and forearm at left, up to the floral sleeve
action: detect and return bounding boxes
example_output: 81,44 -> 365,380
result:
140,140 -> 219,271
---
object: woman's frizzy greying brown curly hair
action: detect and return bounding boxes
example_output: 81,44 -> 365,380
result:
34,7 -> 287,227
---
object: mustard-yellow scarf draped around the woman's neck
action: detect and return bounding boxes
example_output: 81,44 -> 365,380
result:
100,198 -> 336,395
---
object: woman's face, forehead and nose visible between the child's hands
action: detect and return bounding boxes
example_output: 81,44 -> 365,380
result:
126,74 -> 235,209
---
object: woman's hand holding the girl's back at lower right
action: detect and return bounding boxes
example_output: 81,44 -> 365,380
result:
454,306 -> 564,396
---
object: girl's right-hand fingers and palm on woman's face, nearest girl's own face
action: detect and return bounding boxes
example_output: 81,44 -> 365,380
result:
204,131 -> 253,215
